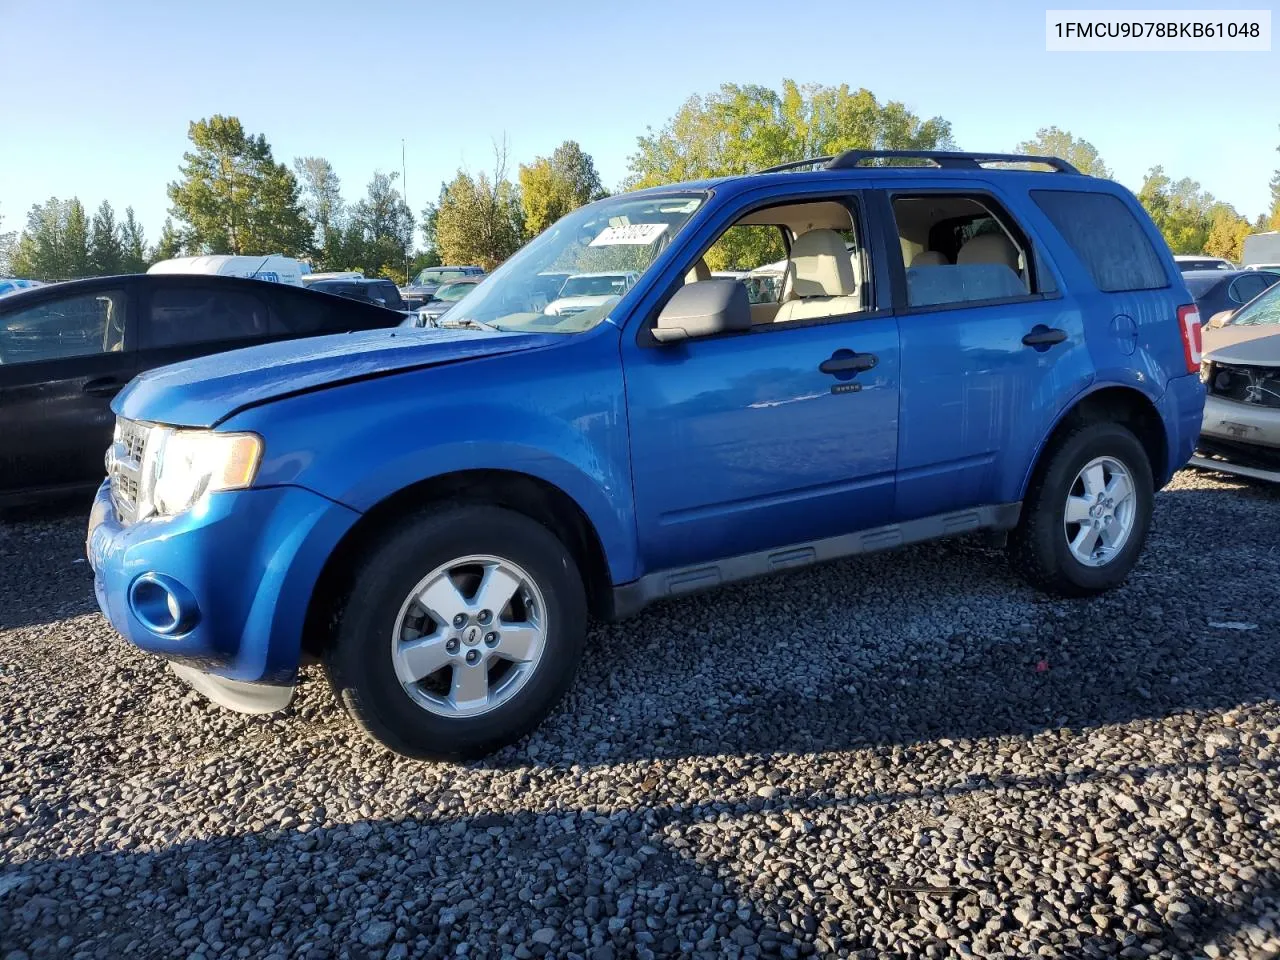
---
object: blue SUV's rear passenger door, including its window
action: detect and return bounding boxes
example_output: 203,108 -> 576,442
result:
877,175 -> 1092,521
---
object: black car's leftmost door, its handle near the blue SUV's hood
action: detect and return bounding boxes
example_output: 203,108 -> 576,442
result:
0,280 -> 137,498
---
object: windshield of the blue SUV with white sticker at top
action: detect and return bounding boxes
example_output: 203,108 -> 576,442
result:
422,193 -> 705,333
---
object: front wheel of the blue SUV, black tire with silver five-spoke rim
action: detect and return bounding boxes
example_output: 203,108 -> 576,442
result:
325,506 -> 586,760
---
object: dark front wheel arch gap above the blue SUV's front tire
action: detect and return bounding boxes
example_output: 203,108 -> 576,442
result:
302,468 -> 613,657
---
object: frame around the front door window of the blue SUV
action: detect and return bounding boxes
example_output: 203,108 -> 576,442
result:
636,182 -> 893,348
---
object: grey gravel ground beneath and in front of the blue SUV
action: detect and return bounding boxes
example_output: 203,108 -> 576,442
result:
0,472 -> 1280,960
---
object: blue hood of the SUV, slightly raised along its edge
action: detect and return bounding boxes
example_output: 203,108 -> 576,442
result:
111,328 -> 557,426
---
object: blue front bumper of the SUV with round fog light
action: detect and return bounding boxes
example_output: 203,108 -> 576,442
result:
86,483 -> 360,701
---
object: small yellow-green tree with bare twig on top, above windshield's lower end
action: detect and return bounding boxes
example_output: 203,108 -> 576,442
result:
422,148 -> 524,270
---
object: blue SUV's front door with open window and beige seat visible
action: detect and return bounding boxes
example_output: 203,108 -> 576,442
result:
623,196 -> 899,572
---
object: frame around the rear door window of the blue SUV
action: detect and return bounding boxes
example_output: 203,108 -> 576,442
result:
876,189 -> 1062,316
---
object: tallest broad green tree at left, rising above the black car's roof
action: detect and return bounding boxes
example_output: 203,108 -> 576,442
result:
168,115 -> 312,256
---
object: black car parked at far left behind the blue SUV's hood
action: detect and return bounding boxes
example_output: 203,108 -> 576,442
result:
0,274 -> 404,507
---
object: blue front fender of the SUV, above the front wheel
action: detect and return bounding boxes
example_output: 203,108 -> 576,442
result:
225,328 -> 639,582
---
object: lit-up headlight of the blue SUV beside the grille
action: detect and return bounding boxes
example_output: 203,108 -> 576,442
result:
140,426 -> 262,517
